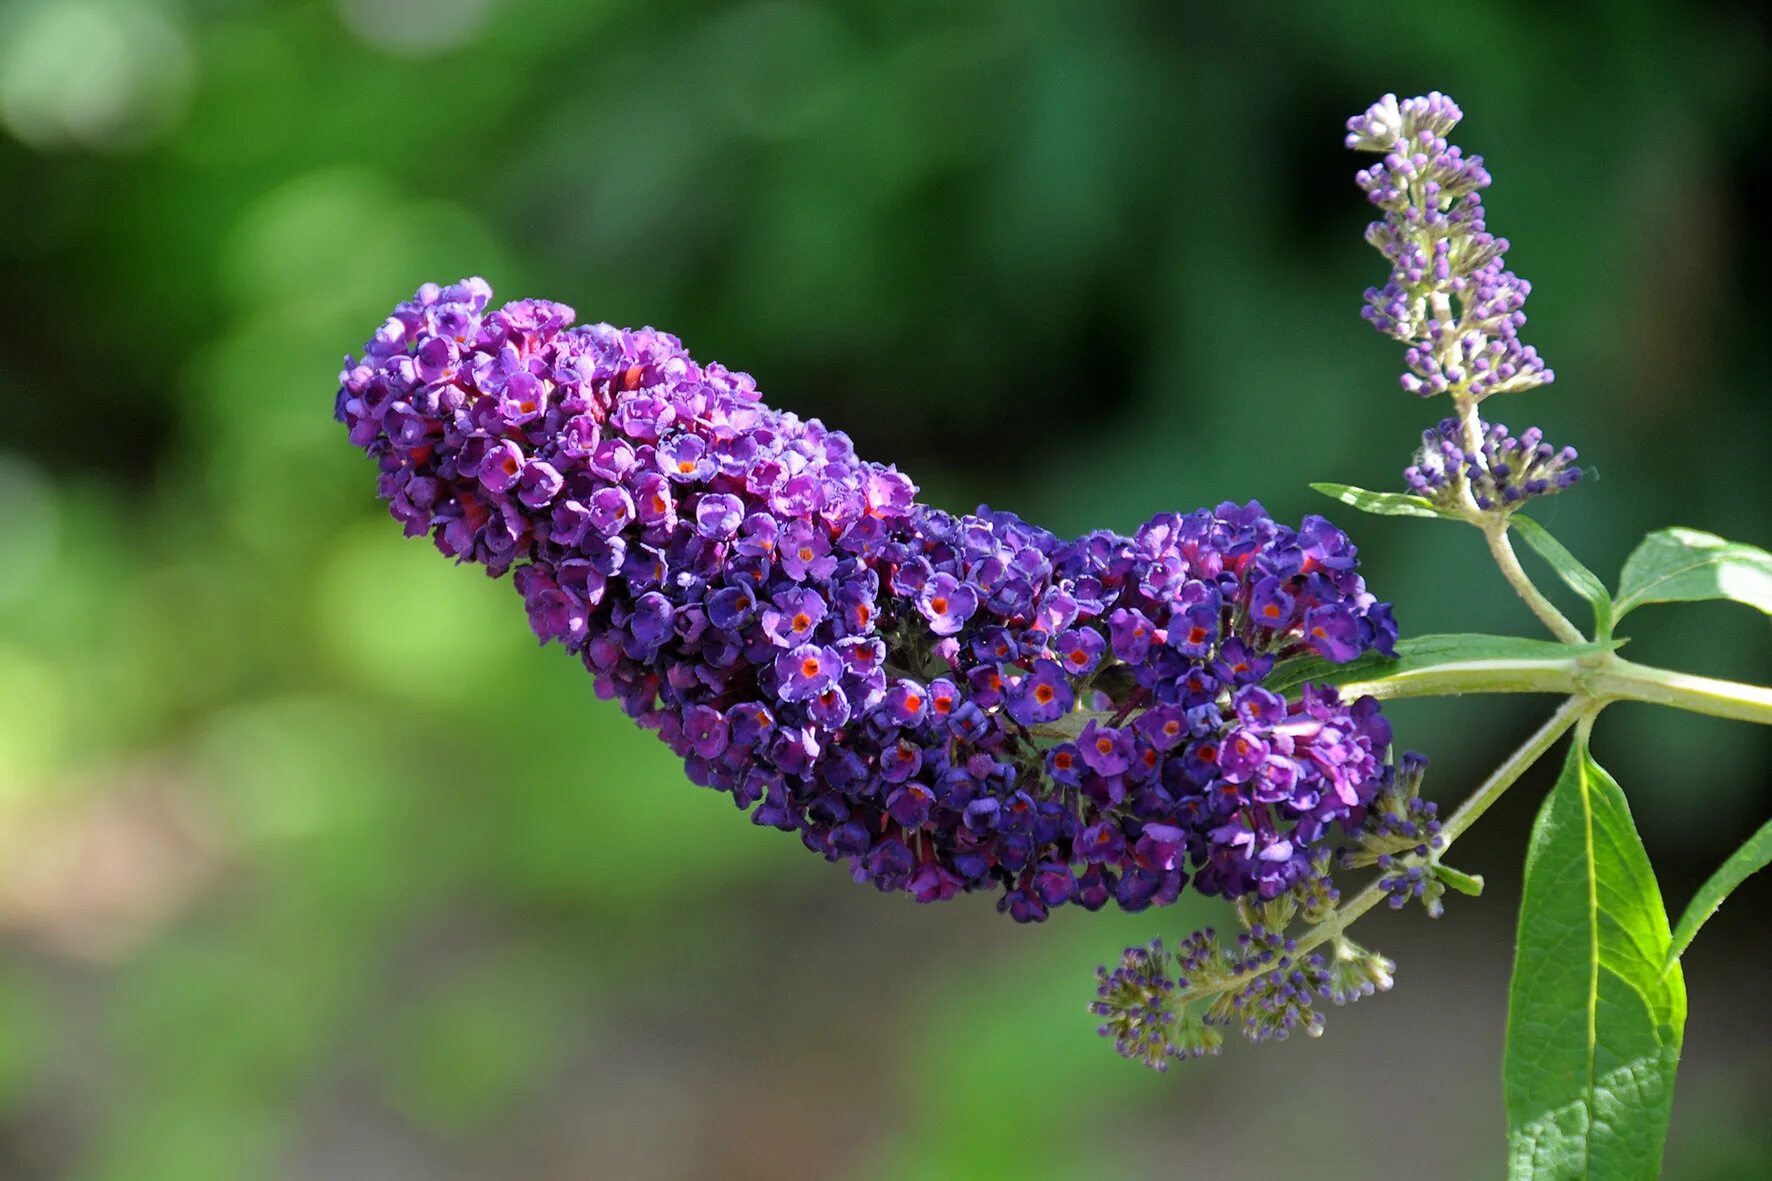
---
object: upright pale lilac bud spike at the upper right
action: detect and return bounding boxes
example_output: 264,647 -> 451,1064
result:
1347,92 -> 1556,399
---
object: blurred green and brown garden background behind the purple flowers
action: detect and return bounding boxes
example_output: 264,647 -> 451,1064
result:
0,0 -> 1772,1181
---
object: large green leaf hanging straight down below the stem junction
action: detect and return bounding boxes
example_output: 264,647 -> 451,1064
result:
1503,736 -> 1685,1181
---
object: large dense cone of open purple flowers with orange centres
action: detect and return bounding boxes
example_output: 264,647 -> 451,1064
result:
337,278 -> 1396,920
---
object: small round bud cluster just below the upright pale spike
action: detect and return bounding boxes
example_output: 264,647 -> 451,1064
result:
1403,418 -> 1581,512
